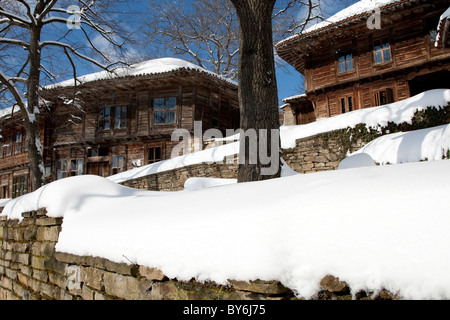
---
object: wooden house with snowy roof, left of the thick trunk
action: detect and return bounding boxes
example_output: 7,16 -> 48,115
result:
0,58 -> 239,198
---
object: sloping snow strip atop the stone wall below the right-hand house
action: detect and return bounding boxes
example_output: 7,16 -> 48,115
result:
280,89 -> 450,149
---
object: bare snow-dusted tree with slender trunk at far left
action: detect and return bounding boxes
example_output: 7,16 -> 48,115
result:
0,0 -> 126,190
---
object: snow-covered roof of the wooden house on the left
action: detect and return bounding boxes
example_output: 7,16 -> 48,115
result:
45,58 -> 237,89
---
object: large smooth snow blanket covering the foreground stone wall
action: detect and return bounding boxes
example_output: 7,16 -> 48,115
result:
2,161 -> 450,299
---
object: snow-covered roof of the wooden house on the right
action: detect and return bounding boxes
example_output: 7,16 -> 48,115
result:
276,0 -> 411,47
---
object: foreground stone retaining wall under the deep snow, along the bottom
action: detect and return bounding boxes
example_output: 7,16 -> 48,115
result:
0,209 -> 397,300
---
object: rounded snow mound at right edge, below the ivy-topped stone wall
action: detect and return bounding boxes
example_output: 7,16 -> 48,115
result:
353,125 -> 450,164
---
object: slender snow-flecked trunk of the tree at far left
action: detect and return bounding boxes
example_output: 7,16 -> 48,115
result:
24,25 -> 45,191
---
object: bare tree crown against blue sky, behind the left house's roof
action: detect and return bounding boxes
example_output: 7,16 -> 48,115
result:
145,0 -> 238,79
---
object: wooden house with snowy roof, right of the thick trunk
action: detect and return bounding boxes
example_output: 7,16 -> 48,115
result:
276,0 -> 450,125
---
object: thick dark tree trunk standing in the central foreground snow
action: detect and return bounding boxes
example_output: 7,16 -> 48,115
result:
231,0 -> 281,182
